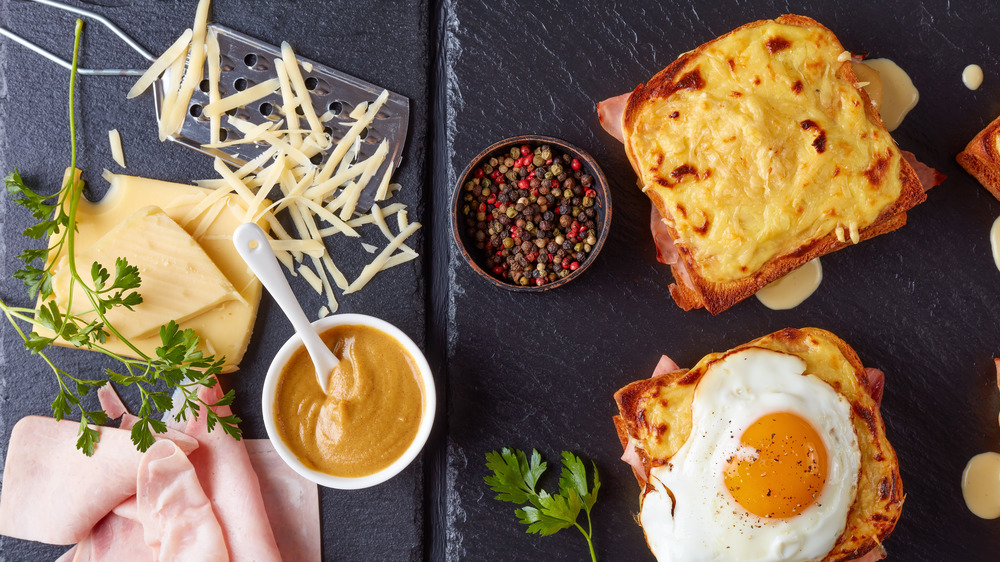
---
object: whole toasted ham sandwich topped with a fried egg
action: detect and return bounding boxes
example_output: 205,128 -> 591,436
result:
614,328 -> 903,562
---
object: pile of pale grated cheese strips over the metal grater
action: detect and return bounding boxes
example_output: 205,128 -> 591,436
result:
128,0 -> 421,317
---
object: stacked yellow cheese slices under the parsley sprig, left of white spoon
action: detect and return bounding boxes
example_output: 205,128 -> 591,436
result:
39,174 -> 267,372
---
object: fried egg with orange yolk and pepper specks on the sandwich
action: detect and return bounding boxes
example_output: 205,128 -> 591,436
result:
639,348 -> 861,562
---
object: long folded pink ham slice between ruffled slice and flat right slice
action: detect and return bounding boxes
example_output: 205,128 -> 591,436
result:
185,383 -> 281,562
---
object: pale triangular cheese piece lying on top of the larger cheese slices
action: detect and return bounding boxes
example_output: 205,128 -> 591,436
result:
52,205 -> 242,340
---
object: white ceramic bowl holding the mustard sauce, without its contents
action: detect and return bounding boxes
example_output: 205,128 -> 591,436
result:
261,314 -> 437,490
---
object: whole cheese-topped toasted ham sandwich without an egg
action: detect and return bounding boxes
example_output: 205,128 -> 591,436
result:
598,15 -> 925,314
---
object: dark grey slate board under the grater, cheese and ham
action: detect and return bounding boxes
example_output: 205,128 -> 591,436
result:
0,0 -> 430,561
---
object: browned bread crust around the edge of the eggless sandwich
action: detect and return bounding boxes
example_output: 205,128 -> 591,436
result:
622,14 -> 920,314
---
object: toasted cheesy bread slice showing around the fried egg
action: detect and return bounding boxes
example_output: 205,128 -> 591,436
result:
614,328 -> 903,561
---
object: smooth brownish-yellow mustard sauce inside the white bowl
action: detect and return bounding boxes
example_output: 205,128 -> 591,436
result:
274,325 -> 423,478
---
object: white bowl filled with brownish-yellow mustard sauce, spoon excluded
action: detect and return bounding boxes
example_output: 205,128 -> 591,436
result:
261,314 -> 437,490
